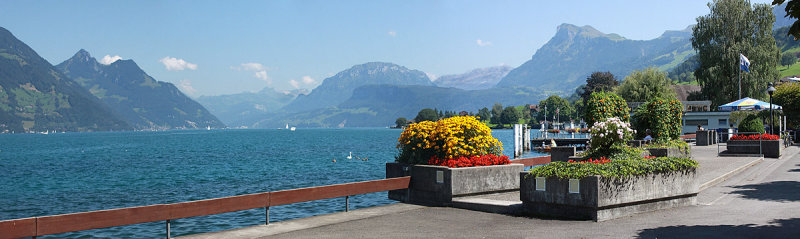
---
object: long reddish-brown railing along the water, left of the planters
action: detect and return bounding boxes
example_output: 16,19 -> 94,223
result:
0,177 -> 411,239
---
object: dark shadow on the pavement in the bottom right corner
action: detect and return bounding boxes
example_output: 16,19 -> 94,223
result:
638,218 -> 800,238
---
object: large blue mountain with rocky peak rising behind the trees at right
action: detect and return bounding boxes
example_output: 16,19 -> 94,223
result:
497,24 -> 694,94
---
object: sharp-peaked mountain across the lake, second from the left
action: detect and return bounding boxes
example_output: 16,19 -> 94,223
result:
56,49 -> 225,130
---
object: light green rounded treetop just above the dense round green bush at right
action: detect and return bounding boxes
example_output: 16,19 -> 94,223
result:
616,67 -> 676,102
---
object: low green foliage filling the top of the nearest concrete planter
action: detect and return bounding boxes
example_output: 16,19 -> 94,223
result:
528,157 -> 697,179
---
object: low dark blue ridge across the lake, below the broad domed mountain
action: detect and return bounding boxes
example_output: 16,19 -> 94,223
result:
253,85 -> 546,128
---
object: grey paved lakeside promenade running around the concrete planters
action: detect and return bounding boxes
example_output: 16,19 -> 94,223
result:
185,145 -> 800,238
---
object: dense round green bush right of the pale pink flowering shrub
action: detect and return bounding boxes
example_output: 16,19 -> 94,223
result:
632,98 -> 683,142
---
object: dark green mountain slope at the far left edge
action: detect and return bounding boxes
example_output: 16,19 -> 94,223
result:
0,27 -> 131,133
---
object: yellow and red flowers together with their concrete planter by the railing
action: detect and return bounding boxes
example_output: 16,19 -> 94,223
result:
386,116 -> 524,206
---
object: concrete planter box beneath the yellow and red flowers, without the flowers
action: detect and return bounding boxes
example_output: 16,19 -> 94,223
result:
386,163 -> 524,206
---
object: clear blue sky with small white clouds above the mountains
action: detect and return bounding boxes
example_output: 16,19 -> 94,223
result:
0,0 -> 772,97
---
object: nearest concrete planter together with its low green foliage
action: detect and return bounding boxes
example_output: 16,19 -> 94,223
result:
520,156 -> 699,221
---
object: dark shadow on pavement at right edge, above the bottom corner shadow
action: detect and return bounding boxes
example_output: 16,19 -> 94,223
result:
731,181 -> 800,202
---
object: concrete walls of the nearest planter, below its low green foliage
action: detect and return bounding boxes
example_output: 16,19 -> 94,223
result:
520,170 -> 699,221
